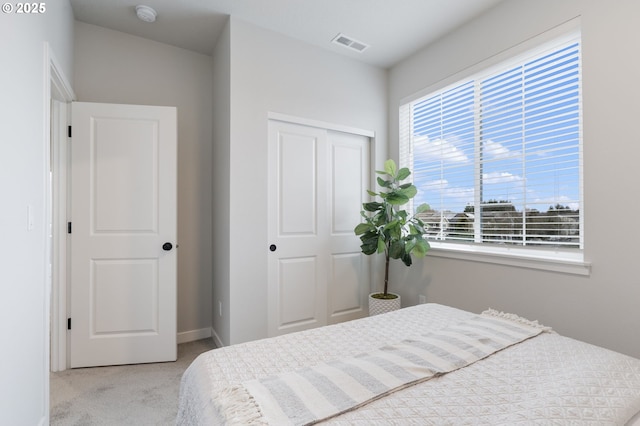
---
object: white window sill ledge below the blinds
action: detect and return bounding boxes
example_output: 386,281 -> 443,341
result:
429,241 -> 591,276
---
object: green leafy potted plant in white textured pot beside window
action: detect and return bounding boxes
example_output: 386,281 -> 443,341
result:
354,160 -> 429,315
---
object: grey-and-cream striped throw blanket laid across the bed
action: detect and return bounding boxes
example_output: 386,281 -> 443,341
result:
214,310 -> 550,425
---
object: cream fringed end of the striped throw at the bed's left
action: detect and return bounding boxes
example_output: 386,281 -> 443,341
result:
214,384 -> 268,426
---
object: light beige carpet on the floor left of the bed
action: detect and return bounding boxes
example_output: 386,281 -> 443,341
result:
50,339 -> 215,426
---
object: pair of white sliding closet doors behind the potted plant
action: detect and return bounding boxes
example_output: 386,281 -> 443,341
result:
268,121 -> 369,336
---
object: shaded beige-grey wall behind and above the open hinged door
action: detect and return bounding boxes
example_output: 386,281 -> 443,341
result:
74,22 -> 213,333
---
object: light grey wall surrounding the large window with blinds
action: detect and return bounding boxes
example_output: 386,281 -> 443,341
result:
389,0 -> 640,357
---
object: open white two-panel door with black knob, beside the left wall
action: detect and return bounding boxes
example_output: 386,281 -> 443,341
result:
70,102 -> 177,368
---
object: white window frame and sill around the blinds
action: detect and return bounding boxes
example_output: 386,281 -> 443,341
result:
398,22 -> 591,275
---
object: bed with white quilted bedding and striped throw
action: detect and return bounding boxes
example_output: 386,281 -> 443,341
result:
176,304 -> 640,425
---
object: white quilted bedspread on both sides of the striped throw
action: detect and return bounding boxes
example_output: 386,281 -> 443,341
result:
176,304 -> 640,425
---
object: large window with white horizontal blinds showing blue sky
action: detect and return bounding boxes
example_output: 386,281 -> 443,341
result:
400,34 -> 584,262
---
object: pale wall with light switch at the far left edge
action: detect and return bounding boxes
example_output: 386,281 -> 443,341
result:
0,0 -> 73,425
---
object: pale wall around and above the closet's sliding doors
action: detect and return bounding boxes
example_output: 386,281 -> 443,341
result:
213,18 -> 387,344
